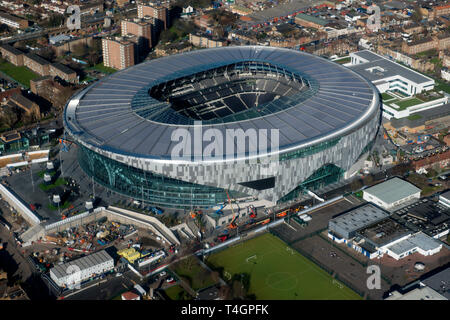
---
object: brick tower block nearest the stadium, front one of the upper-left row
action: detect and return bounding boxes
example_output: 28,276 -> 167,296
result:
102,37 -> 136,70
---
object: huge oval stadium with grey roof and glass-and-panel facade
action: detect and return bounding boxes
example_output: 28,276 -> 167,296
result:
64,46 -> 381,208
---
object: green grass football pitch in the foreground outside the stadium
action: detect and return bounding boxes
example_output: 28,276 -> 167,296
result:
207,233 -> 362,300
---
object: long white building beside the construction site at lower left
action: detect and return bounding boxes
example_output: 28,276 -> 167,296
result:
50,250 -> 114,288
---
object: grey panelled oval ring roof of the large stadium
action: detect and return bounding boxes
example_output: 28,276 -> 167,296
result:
64,46 -> 380,160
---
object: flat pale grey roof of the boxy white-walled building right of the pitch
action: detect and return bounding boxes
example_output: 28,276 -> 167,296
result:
364,177 -> 421,204
